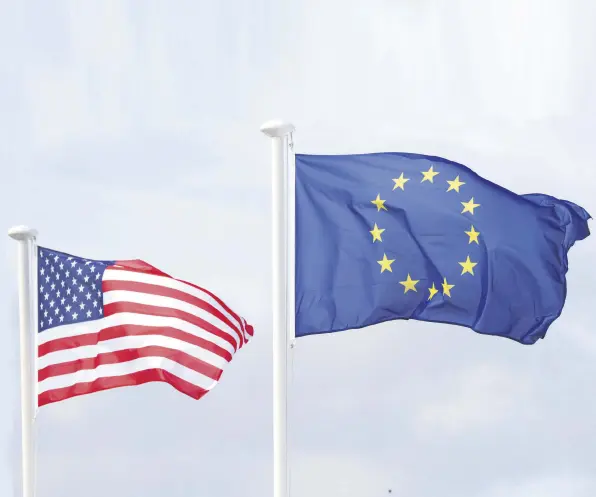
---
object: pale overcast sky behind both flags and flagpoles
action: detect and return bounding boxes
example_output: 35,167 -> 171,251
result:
0,0 -> 596,497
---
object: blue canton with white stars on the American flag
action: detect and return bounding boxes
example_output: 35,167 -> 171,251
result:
37,247 -> 114,332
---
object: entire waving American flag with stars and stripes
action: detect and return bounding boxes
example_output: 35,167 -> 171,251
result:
37,247 -> 253,406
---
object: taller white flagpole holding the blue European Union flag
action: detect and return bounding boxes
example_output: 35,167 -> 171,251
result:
261,120 -> 294,497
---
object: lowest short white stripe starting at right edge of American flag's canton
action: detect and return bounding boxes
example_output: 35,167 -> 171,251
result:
103,290 -> 241,345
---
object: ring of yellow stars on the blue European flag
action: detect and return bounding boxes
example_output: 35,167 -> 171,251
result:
369,166 -> 481,301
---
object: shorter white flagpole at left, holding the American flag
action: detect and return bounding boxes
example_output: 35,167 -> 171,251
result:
8,226 -> 37,497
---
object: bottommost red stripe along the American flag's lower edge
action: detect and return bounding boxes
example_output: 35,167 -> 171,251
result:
38,369 -> 208,407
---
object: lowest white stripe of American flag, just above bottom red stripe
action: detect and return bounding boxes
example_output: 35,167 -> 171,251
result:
39,357 -> 217,394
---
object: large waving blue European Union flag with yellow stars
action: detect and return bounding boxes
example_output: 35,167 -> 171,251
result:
296,153 -> 590,344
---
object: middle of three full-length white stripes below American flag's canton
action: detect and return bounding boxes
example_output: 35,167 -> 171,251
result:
37,335 -> 228,369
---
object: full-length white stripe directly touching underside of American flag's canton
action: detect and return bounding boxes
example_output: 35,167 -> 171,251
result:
38,312 -> 234,354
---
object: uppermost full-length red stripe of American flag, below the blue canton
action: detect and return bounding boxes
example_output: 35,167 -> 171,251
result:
37,324 -> 232,362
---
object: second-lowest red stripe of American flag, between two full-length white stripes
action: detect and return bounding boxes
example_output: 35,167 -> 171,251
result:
37,345 -> 222,381
